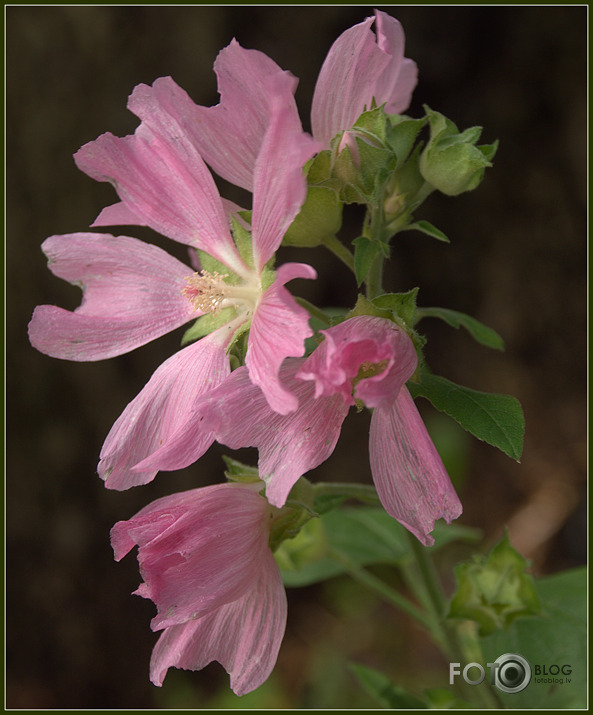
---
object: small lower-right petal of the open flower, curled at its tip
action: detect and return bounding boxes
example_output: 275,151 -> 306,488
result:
245,263 -> 317,414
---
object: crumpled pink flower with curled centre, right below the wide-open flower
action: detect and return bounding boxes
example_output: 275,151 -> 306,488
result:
142,316 -> 462,545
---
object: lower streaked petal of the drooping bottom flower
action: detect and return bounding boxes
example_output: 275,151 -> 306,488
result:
150,552 -> 287,695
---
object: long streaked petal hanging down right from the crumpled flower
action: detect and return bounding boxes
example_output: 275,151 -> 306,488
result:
369,387 -> 462,546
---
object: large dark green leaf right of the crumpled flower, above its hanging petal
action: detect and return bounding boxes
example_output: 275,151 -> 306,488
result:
408,371 -> 525,462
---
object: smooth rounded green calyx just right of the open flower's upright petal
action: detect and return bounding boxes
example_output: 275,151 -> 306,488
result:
282,186 -> 342,247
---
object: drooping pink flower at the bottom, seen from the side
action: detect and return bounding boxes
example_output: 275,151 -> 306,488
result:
111,482 -> 287,695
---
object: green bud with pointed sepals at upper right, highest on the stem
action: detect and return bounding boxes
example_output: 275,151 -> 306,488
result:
419,107 -> 498,196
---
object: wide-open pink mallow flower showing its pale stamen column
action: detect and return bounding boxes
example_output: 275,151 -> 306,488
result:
29,80 -> 316,489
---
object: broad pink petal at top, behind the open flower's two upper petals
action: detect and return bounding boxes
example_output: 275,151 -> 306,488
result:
193,39 -> 298,191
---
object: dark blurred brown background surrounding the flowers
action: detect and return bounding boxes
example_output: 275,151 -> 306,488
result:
6,5 -> 588,709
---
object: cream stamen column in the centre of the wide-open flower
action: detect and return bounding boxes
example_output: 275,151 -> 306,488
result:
182,271 -> 261,313
